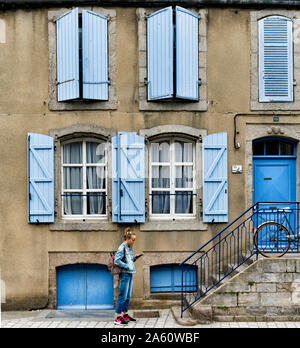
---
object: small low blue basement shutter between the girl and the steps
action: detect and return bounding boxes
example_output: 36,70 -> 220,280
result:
150,264 -> 197,292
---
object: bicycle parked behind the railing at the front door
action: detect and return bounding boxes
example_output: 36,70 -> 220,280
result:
253,207 -> 300,258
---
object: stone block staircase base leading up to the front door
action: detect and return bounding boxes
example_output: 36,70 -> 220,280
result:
172,256 -> 300,325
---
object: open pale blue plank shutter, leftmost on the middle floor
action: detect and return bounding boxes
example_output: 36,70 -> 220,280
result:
27,133 -> 54,223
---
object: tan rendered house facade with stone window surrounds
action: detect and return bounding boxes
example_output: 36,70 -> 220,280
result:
0,0 -> 300,309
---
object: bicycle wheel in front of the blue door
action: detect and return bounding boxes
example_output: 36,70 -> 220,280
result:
254,221 -> 291,258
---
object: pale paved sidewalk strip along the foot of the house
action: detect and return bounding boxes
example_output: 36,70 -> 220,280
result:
1,309 -> 300,329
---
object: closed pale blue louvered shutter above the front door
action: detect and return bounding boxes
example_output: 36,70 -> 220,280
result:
259,16 -> 293,102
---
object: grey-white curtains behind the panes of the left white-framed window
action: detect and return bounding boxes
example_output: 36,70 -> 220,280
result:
63,142 -> 106,215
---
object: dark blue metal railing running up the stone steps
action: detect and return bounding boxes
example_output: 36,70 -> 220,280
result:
179,202 -> 300,316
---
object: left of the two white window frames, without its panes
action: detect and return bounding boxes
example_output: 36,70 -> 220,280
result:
61,137 -> 108,220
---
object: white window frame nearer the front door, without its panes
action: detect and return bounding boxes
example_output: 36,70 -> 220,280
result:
149,137 -> 197,220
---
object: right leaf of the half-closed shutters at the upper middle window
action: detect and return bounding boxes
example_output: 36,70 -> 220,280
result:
176,6 -> 199,100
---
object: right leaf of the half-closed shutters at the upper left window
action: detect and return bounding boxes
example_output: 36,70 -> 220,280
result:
82,10 -> 108,100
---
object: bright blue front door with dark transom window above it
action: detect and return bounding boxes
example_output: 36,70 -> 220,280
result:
253,138 -> 297,247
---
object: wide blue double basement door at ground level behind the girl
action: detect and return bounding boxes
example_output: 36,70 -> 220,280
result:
56,264 -> 114,310
